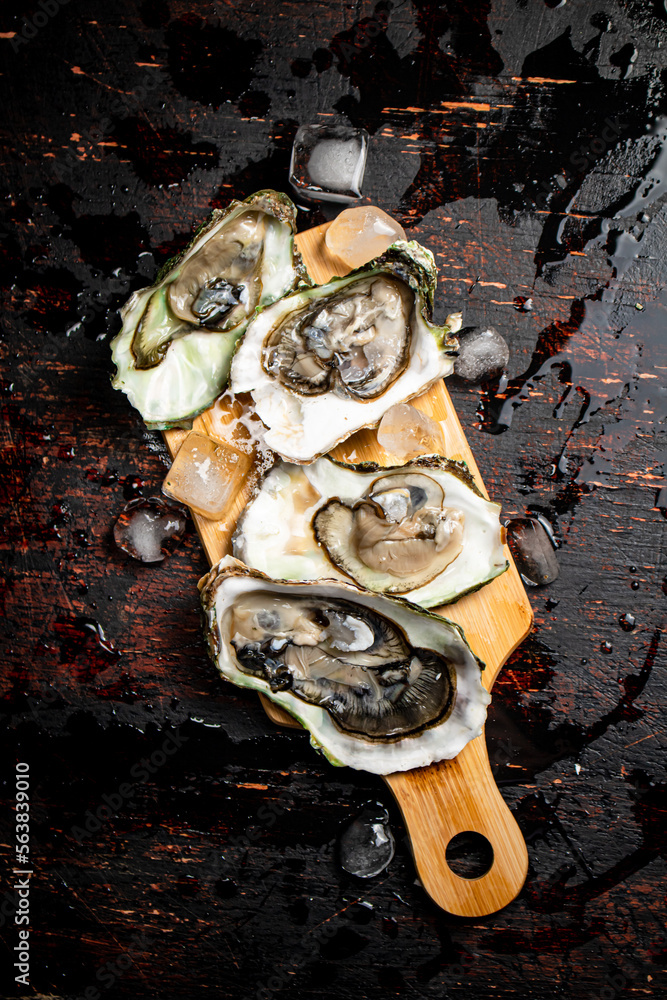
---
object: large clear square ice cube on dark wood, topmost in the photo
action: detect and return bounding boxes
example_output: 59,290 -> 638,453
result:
289,125 -> 368,203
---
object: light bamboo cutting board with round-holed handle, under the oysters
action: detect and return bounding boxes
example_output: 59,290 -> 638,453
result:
164,224 -> 533,917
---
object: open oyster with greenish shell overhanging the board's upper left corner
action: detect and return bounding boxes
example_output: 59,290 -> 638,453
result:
111,191 -> 310,428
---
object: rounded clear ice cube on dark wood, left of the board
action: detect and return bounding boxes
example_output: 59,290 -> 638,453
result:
113,497 -> 187,562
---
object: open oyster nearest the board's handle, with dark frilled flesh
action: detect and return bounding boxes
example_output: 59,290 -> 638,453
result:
200,556 -> 490,774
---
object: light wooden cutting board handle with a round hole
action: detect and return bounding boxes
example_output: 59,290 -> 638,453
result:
385,734 -> 528,917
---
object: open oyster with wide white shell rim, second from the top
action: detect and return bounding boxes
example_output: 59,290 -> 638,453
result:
230,241 -> 457,462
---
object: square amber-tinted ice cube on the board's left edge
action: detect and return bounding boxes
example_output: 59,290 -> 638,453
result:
162,431 -> 252,520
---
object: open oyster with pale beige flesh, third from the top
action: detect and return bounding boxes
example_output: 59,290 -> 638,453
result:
234,455 -> 508,608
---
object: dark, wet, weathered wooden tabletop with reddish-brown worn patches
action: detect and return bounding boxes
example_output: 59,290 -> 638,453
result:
0,0 -> 667,1000
